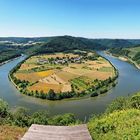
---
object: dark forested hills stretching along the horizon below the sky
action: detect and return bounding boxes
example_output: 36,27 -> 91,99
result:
0,36 -> 140,62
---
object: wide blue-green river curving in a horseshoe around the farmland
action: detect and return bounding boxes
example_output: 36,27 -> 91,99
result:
0,52 -> 140,120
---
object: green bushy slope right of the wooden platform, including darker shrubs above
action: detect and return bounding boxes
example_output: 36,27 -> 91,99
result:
88,93 -> 140,140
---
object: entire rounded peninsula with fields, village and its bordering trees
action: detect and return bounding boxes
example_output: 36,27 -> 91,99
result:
10,50 -> 117,100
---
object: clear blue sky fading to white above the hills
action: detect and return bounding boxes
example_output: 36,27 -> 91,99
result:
0,0 -> 140,39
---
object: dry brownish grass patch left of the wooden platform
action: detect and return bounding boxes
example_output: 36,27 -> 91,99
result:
0,125 -> 27,140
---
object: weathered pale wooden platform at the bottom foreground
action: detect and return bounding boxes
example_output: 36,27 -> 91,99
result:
21,124 -> 92,140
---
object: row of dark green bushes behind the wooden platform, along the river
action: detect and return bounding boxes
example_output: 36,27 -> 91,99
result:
0,99 -> 81,127
